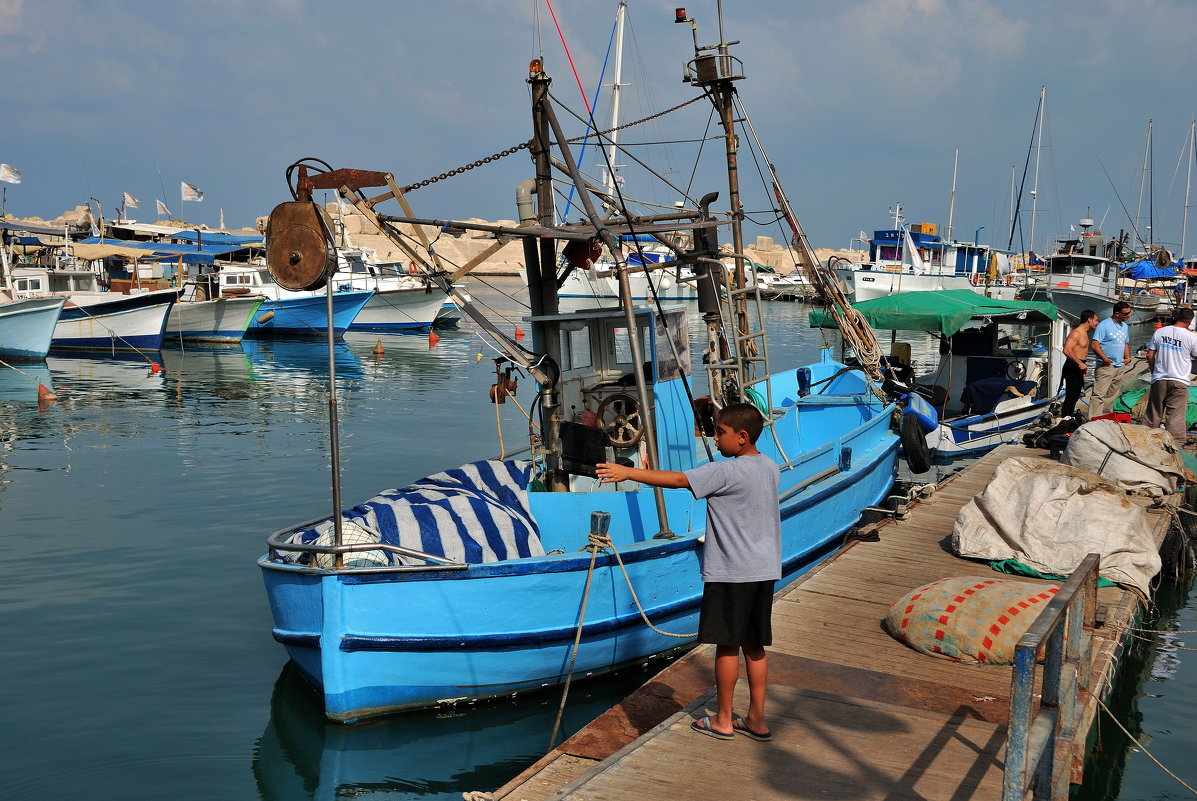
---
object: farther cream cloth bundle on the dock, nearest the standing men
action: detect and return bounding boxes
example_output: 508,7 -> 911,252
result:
1061,420 -> 1191,498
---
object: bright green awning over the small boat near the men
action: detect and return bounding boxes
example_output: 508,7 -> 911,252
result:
808,290 -> 1059,336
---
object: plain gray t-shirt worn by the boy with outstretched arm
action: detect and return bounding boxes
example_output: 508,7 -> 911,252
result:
686,454 -> 782,583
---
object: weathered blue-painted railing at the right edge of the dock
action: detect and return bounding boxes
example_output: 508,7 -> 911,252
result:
1002,553 -> 1100,801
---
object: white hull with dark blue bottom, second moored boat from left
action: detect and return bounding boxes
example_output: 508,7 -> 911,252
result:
50,290 -> 178,351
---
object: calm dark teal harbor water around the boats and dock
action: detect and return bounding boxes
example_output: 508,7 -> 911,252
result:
0,279 -> 1197,801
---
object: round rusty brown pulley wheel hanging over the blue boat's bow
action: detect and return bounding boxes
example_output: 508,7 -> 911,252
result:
266,200 -> 336,292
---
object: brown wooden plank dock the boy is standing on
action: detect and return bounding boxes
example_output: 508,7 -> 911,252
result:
493,445 -> 1168,801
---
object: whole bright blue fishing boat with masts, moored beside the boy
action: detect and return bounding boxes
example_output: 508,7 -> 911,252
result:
259,6 -> 899,722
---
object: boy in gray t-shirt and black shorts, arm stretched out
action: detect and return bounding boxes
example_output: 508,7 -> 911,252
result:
599,403 -> 782,741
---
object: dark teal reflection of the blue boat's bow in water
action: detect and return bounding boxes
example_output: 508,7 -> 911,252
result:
253,663 -> 661,801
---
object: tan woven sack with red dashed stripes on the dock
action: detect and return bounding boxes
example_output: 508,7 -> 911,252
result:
885,576 -> 1059,665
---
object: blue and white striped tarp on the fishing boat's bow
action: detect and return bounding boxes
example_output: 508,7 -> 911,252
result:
280,460 -> 545,564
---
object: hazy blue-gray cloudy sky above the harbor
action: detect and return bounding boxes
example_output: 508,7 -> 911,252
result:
0,0 -> 1197,255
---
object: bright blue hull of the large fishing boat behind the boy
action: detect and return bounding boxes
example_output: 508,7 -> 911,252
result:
259,364 -> 898,722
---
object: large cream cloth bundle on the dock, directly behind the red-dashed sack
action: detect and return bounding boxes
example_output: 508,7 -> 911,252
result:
952,456 -> 1160,595
